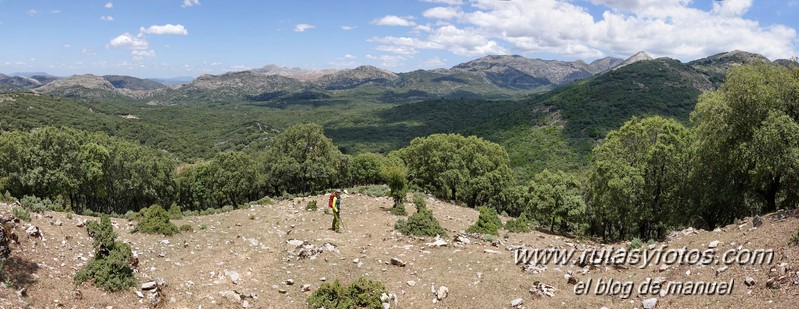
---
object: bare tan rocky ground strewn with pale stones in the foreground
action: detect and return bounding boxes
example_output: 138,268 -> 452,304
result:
0,194 -> 799,308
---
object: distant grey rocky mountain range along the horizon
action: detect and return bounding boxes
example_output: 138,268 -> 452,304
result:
6,51 -> 790,105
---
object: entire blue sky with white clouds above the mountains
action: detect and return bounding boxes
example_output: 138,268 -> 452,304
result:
0,0 -> 799,78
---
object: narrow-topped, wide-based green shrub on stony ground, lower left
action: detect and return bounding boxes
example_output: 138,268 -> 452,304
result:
74,216 -> 134,292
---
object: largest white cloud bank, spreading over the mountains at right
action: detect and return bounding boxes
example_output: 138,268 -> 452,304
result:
370,0 -> 798,60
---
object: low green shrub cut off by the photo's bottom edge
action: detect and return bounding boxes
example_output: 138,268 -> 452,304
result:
307,277 -> 387,309
